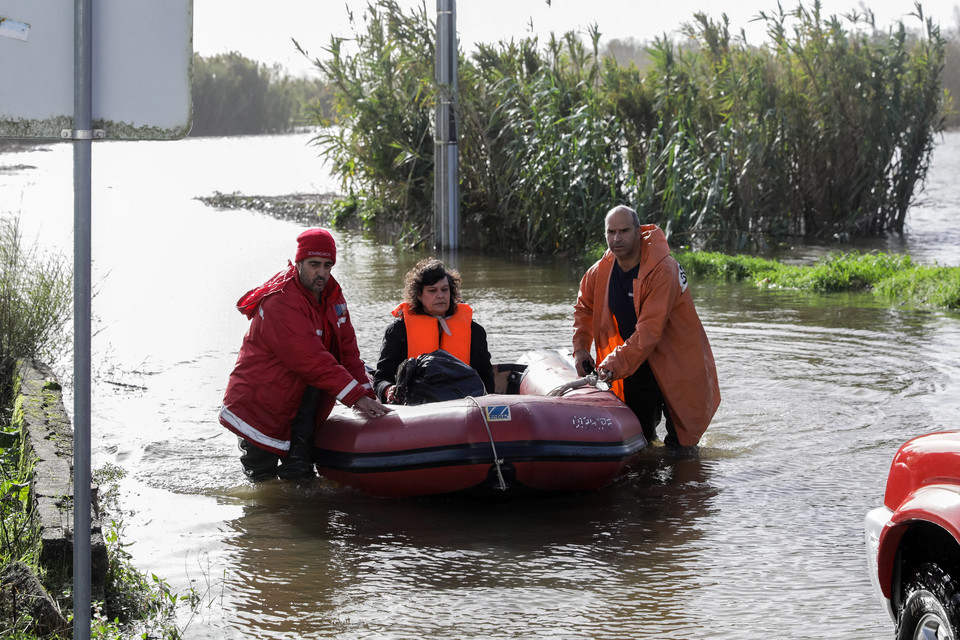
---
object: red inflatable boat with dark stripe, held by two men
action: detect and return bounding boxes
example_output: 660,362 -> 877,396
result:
314,351 -> 647,497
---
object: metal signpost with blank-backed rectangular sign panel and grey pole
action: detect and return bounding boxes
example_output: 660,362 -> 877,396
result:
0,0 -> 193,640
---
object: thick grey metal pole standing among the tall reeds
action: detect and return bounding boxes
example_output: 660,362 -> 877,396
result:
433,0 -> 460,249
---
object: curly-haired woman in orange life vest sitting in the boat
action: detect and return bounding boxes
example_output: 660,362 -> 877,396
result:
373,258 -> 494,402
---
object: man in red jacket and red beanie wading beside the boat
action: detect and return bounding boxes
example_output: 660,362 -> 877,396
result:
220,229 -> 390,480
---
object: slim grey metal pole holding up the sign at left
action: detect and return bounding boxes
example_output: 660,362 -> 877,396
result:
73,0 -> 93,640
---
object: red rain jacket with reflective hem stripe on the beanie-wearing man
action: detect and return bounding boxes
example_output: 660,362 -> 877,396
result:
220,264 -> 374,455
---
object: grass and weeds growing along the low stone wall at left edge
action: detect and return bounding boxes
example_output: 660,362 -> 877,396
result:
0,218 -> 197,640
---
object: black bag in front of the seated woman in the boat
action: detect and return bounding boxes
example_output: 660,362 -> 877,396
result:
395,349 -> 486,405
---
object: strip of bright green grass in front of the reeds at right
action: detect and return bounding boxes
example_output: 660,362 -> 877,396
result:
675,251 -> 960,310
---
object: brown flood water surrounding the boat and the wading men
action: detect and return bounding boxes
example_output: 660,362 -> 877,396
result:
0,134 -> 960,640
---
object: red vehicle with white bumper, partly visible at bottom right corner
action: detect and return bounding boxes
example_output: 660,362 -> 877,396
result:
865,432 -> 960,640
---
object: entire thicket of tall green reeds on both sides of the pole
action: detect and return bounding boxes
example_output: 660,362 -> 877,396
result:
308,0 -> 945,253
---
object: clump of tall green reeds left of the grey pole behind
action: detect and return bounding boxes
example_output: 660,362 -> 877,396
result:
298,0 -> 435,235
